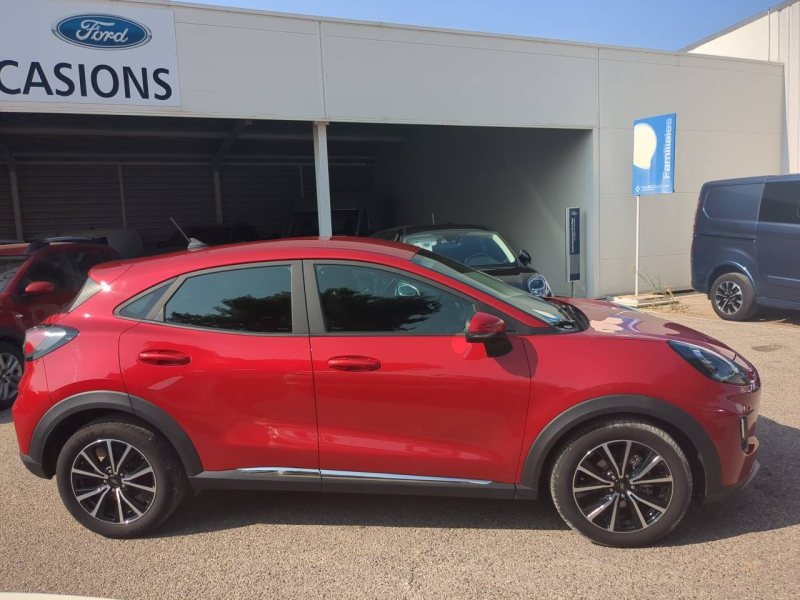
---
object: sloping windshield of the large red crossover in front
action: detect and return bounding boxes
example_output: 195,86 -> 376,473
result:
411,250 -> 565,325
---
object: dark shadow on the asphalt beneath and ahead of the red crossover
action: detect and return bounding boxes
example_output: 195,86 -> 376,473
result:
156,417 -> 800,546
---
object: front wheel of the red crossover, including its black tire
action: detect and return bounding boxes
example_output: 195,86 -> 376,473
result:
550,419 -> 692,548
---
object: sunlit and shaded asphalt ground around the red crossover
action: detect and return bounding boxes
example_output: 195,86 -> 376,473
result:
0,313 -> 800,600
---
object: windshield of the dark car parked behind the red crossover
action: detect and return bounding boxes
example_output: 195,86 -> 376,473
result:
403,229 -> 517,269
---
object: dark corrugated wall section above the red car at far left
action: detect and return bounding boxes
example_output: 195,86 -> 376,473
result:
15,163 -> 122,239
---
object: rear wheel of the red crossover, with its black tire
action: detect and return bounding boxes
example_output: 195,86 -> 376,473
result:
56,417 -> 188,538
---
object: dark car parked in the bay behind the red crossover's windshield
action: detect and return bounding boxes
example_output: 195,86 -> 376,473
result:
372,223 -> 553,297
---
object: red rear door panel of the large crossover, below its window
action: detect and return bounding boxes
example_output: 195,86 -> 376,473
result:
119,323 -> 319,471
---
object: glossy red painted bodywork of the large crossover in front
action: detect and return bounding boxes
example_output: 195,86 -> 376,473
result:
14,238 -> 760,502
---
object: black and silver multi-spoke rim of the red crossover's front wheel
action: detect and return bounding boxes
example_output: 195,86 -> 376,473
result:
572,440 -> 674,533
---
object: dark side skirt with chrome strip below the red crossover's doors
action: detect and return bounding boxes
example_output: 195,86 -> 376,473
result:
189,467 -> 517,499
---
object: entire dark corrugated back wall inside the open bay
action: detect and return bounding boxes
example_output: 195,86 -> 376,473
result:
9,163 -> 372,250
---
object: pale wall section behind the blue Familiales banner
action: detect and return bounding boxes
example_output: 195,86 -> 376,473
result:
599,48 -> 782,295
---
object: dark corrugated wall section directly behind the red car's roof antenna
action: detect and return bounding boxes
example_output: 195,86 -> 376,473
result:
122,165 -> 216,249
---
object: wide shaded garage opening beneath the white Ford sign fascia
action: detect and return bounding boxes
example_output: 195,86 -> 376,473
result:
0,113 -> 596,296
